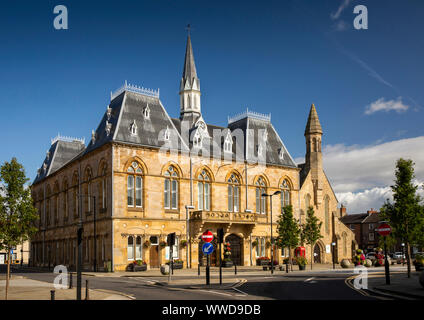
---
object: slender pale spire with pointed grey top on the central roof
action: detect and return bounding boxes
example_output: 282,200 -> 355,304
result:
180,35 -> 201,127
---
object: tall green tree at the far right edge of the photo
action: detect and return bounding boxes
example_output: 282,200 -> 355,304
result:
380,158 -> 423,278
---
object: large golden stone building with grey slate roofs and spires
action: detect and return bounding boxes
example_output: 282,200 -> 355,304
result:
31,36 -> 354,270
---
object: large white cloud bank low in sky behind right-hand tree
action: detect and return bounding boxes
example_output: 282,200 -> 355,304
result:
323,136 -> 424,213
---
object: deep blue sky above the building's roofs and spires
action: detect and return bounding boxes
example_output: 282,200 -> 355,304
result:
0,0 -> 424,210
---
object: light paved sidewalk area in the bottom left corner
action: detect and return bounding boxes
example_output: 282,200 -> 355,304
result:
0,276 -> 132,300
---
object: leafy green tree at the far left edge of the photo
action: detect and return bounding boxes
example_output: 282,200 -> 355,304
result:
0,158 -> 38,300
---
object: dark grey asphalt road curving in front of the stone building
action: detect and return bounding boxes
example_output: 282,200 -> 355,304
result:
0,267 -> 404,300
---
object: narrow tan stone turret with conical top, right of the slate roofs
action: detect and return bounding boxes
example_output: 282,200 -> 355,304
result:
305,104 -> 324,206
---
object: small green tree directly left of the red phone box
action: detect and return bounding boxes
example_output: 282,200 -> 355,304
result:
277,205 -> 300,270
